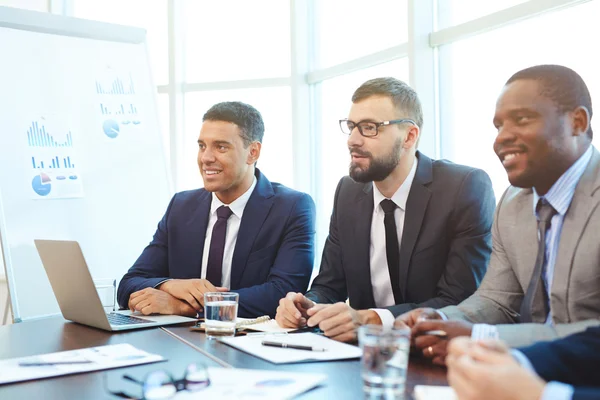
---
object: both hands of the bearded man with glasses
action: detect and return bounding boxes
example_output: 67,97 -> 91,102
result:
275,292 -> 381,342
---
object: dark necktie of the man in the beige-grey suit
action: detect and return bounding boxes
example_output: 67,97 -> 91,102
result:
521,199 -> 556,323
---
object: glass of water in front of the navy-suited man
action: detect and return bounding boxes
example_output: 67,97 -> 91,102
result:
204,292 -> 239,339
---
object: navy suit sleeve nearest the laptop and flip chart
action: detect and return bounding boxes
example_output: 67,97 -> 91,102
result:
117,195 -> 177,308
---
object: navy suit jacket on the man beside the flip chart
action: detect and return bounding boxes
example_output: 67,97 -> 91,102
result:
118,169 -> 315,317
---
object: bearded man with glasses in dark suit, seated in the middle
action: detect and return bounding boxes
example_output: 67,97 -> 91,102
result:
276,78 -> 495,341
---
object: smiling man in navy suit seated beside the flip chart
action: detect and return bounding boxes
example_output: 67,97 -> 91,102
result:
118,102 -> 315,317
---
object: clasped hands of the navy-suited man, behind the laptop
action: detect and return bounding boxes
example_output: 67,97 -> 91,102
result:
128,279 -> 228,317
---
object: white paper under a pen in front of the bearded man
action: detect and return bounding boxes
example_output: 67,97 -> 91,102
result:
221,333 -> 362,364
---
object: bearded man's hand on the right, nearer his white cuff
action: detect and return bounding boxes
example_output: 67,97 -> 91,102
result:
307,303 -> 381,342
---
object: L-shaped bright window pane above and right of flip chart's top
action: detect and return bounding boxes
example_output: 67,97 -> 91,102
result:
73,0 -> 169,85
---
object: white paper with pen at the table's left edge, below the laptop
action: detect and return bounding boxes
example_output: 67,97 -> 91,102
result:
0,343 -> 164,385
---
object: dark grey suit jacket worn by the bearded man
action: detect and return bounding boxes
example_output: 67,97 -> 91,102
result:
306,152 -> 496,316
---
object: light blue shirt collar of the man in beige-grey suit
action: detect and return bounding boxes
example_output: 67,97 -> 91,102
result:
533,146 -> 593,215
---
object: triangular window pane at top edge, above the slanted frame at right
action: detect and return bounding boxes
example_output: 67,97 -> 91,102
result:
437,0 -> 528,29
